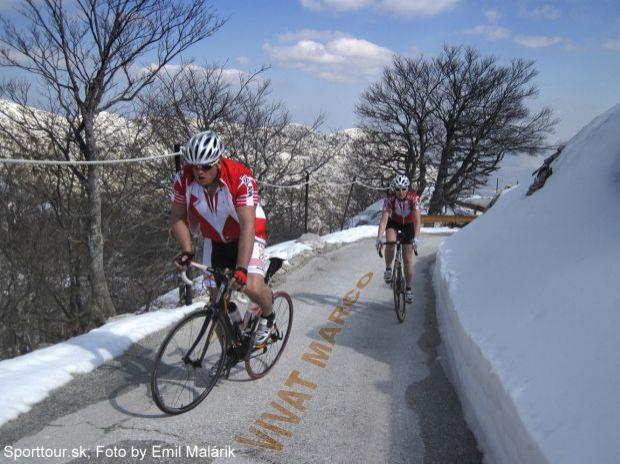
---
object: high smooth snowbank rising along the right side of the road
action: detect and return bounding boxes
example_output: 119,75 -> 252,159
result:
434,105 -> 620,464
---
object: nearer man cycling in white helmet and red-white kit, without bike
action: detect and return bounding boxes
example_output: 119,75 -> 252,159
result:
170,130 -> 274,344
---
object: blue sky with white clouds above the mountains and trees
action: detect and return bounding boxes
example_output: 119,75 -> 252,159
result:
0,0 -> 620,141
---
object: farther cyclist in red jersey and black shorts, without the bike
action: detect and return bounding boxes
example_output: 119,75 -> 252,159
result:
376,174 -> 422,303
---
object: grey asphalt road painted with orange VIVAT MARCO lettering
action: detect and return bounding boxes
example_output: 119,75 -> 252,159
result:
0,236 -> 482,464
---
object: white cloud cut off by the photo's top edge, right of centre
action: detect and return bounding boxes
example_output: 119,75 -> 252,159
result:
300,0 -> 460,16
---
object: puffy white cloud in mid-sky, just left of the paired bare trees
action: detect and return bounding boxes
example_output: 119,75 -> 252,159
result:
263,29 -> 393,82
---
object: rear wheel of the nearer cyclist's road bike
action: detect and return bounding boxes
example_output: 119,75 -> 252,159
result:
245,292 -> 293,379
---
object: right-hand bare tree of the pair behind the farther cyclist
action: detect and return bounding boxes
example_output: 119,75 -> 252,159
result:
429,46 -> 555,214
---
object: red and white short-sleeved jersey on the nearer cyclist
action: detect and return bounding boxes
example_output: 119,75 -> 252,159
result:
172,157 -> 267,243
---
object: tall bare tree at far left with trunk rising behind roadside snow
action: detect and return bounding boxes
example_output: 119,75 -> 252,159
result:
0,0 -> 224,323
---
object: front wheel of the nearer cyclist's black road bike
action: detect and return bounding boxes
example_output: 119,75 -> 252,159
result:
151,309 -> 228,414
